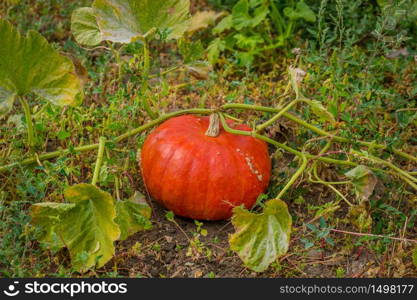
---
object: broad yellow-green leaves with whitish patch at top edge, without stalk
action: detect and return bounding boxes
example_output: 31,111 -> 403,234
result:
72,0 -> 190,46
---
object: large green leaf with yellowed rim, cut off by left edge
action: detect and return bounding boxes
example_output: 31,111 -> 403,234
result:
0,19 -> 82,113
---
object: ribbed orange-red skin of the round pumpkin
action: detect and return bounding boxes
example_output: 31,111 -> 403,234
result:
141,115 -> 271,220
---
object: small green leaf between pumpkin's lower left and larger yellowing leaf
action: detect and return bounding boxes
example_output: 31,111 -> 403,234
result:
115,192 -> 152,241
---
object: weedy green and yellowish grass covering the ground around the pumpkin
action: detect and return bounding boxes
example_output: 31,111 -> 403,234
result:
0,0 -> 417,277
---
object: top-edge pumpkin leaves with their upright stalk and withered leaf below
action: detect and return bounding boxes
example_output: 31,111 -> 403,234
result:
71,0 -> 213,119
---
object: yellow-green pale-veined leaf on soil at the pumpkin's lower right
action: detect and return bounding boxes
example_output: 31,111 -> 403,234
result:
229,199 -> 292,272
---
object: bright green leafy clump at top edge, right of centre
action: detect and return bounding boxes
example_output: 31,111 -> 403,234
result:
209,0 -> 316,67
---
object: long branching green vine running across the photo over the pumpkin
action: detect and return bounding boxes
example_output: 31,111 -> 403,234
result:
0,103 -> 417,195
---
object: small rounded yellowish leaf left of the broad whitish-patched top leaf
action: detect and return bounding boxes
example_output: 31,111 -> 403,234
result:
71,7 -> 103,46
